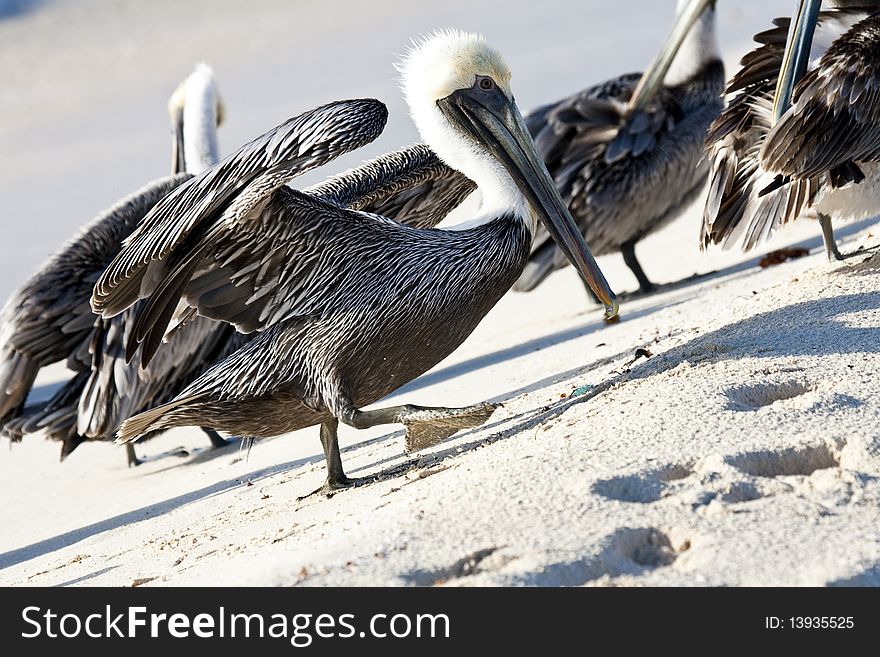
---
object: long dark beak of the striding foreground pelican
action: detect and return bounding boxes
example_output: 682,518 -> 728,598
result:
437,83 -> 618,319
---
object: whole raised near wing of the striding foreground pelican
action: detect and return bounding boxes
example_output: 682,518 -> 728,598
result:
92,99 -> 388,365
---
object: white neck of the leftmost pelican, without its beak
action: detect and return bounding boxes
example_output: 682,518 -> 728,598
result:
183,65 -> 220,174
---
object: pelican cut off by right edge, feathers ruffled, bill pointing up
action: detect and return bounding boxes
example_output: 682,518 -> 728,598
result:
701,0 -> 880,260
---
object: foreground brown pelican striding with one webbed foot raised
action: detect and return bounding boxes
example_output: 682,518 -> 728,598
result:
92,31 -> 617,490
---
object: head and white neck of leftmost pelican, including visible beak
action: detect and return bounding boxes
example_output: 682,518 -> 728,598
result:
168,63 -> 226,173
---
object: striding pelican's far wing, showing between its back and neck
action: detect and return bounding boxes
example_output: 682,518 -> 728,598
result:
304,144 -> 476,228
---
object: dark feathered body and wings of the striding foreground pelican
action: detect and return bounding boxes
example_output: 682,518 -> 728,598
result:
87,101 -> 508,438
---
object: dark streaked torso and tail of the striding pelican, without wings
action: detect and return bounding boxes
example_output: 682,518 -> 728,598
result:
129,208 -> 531,437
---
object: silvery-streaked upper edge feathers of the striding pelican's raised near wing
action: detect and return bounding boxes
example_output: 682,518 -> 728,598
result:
92,99 -> 388,322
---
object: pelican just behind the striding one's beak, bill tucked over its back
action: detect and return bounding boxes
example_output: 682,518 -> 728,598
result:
514,0 -> 724,292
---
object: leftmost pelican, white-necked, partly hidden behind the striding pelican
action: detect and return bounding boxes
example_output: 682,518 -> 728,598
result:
0,64 -> 244,465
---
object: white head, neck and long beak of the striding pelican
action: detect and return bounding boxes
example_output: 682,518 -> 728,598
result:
398,30 -> 617,317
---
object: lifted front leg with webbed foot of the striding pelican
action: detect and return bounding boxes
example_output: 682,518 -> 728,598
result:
339,403 -> 496,452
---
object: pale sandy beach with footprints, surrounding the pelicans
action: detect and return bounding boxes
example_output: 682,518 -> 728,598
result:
0,0 -> 880,585
